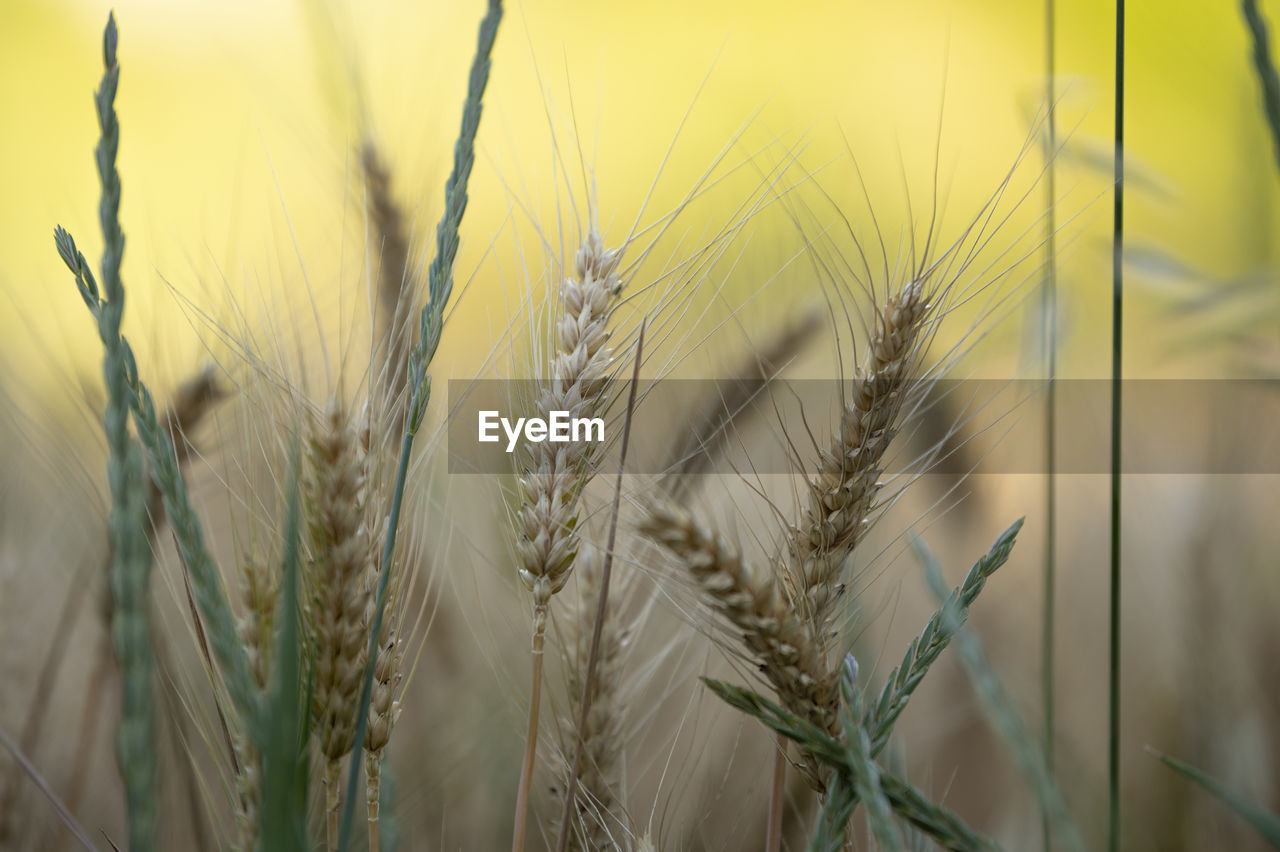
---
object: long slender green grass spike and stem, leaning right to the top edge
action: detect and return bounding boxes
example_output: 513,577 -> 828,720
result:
338,0 -> 502,852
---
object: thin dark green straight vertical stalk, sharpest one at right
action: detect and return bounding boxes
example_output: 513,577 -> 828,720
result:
1107,0 -> 1125,852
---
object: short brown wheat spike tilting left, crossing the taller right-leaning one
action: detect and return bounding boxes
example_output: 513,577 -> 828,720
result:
640,505 -> 837,762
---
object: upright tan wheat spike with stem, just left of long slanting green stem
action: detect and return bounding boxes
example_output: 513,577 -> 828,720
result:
305,403 -> 376,848
